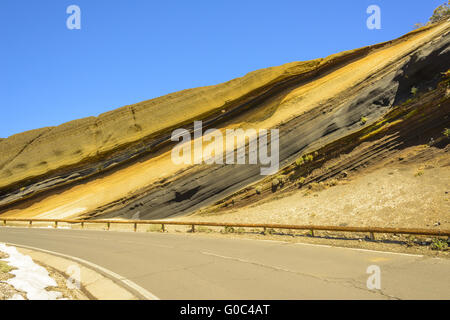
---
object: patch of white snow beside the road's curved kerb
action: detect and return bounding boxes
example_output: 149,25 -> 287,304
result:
0,243 -> 62,300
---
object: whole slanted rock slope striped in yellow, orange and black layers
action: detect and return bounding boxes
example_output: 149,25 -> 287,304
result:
0,22 -> 450,219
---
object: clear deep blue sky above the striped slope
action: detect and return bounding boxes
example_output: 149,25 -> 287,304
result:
0,0 -> 445,138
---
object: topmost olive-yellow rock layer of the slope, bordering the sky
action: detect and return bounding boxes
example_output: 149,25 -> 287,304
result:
0,59 -> 322,188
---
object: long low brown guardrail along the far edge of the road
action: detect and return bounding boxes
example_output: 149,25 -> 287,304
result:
0,218 -> 450,239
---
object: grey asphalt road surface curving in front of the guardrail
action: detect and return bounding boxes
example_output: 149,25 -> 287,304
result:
0,227 -> 450,299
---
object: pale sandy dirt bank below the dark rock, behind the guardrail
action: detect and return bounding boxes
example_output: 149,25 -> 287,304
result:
187,146 -> 450,230
